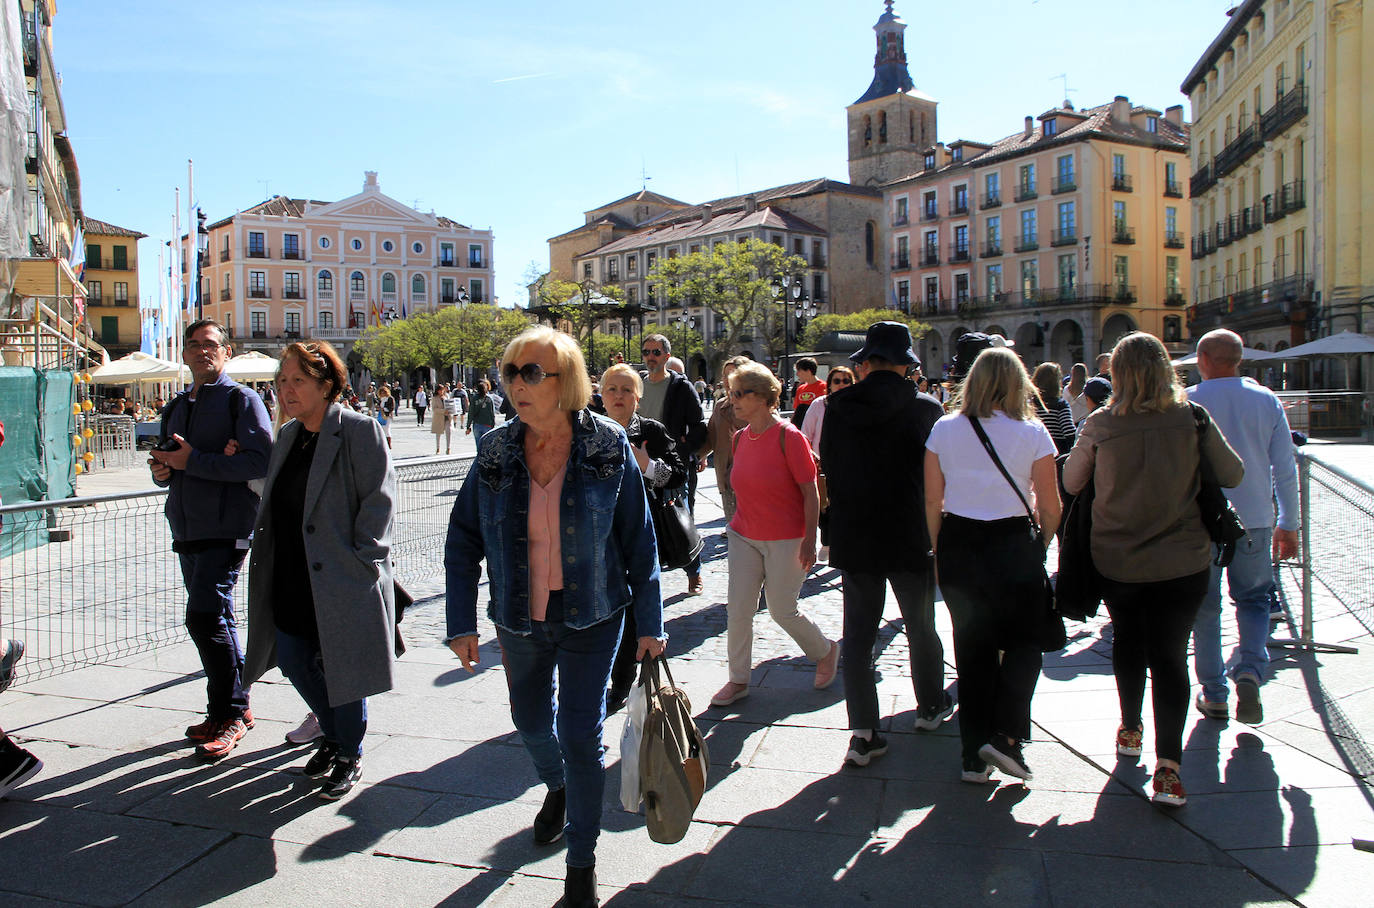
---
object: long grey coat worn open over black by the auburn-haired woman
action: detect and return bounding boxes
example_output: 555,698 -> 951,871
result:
245,402 -> 396,706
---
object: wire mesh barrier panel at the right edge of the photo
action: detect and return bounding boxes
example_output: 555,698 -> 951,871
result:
1270,451 -> 1374,652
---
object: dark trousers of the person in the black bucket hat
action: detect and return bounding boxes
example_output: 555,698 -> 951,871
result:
841,570 -> 944,729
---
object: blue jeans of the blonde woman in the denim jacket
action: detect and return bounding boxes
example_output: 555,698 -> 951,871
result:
496,593 -> 622,867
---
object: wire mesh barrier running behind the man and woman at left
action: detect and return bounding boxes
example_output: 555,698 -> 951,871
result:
0,456 -> 473,680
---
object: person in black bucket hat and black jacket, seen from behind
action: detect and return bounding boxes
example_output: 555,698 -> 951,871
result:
820,321 -> 954,767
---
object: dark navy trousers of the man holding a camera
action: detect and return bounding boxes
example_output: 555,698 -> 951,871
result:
179,545 -> 249,721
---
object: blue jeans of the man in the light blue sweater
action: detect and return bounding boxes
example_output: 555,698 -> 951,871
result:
1193,529 -> 1274,703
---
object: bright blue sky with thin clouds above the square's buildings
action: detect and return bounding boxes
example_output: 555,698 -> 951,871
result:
54,0 -> 1231,305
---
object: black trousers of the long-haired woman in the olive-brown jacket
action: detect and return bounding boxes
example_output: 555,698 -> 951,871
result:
1102,570 -> 1209,762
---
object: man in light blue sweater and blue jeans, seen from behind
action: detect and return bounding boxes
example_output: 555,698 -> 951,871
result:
1189,328 -> 1298,725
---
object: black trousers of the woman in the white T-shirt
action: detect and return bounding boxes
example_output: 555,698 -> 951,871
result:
936,514 -> 1044,765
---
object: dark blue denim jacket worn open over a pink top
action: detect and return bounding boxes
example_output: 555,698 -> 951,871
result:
444,409 -> 664,639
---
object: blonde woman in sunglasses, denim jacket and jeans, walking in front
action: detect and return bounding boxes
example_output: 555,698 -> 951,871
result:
444,327 -> 664,905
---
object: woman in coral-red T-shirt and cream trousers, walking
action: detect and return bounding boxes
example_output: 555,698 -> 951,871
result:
710,363 -> 840,706
